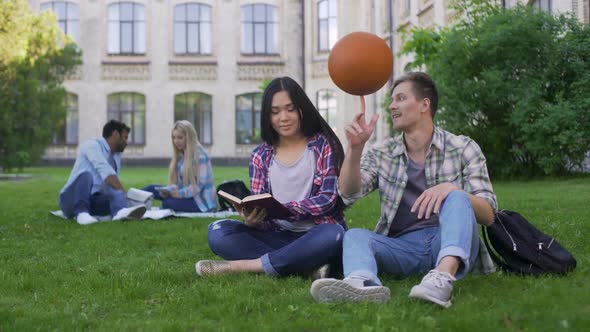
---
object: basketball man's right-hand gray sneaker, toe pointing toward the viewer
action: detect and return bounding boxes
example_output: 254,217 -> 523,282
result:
410,270 -> 457,308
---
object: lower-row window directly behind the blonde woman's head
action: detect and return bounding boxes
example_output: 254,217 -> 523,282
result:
174,92 -> 213,145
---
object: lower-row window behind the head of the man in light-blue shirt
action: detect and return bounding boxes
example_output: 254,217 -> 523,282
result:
107,92 -> 145,145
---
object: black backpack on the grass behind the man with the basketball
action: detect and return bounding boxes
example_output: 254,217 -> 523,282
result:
482,210 -> 576,276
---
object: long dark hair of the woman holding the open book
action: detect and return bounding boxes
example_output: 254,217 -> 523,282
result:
260,76 -> 345,211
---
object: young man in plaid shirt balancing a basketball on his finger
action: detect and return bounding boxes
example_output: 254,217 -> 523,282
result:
311,72 -> 497,307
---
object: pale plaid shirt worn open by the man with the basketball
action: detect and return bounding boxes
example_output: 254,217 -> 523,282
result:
340,127 -> 498,272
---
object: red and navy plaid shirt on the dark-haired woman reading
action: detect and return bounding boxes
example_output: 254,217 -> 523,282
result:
250,134 -> 346,229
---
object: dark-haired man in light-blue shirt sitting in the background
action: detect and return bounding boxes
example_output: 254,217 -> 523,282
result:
59,120 -> 146,225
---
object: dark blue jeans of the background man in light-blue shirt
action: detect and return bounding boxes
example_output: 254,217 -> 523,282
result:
59,172 -> 127,218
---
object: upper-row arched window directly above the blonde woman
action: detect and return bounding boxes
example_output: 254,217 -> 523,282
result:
174,3 -> 211,54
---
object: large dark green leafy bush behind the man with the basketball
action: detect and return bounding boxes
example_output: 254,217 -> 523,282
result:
404,0 -> 590,176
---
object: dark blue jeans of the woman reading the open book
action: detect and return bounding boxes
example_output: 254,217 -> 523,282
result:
209,219 -> 344,276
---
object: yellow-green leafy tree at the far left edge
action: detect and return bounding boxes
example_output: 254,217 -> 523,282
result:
0,0 -> 81,170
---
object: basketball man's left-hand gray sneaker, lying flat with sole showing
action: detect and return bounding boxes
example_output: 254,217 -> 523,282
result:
310,277 -> 391,303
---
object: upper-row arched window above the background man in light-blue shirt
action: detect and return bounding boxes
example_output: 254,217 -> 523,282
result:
108,2 -> 146,54
